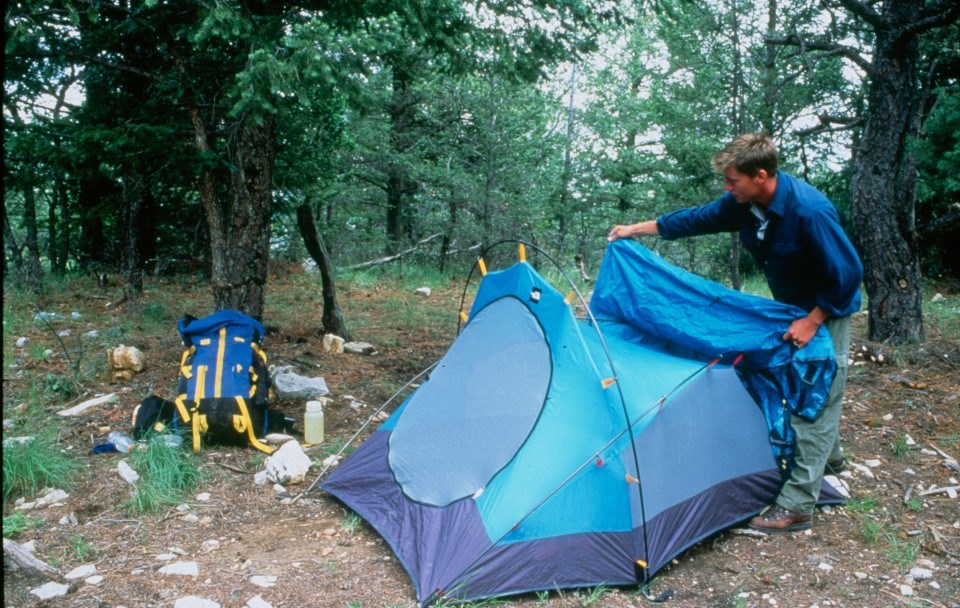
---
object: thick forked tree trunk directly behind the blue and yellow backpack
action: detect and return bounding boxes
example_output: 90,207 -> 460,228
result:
201,117 -> 276,320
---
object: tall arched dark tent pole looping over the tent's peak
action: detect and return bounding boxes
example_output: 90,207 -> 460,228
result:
457,239 -> 656,582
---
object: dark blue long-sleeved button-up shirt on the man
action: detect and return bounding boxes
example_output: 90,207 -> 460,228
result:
657,171 -> 863,317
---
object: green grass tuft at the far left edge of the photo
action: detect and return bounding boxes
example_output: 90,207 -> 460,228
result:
3,431 -> 80,502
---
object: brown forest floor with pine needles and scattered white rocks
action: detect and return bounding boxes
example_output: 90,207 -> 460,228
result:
3,268 -> 960,608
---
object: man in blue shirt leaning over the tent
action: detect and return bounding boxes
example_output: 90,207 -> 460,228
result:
607,133 -> 863,533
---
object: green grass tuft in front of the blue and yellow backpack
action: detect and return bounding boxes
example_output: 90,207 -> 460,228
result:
125,437 -> 205,514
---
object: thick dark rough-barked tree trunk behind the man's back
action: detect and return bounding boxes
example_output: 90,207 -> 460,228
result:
850,0 -> 923,343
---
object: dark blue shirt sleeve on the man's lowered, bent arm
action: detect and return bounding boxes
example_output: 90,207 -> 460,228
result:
807,209 -> 863,316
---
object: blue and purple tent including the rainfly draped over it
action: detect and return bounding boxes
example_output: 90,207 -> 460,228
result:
322,241 -> 842,605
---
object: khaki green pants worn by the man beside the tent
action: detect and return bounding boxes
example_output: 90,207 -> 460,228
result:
777,317 -> 850,515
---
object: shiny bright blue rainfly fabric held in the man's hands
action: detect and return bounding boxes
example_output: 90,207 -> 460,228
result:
590,240 -> 837,470
